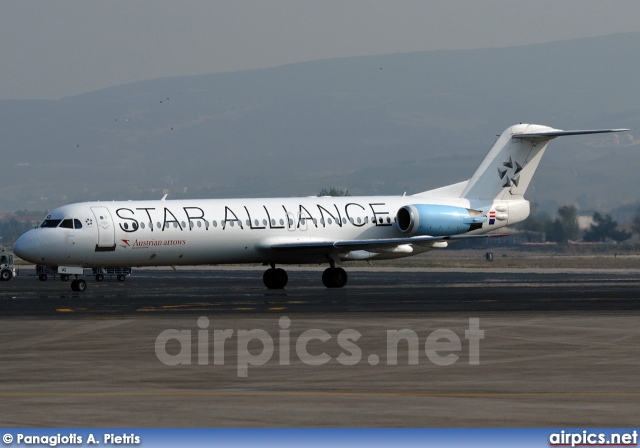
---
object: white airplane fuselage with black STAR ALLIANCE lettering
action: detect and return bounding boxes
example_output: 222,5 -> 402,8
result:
15,196 -> 508,267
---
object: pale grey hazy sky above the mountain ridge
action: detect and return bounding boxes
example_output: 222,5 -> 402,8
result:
0,0 -> 640,99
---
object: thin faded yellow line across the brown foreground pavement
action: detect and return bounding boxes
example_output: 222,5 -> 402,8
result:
0,389 -> 640,398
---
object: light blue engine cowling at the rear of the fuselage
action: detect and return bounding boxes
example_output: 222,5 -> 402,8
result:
396,204 -> 487,236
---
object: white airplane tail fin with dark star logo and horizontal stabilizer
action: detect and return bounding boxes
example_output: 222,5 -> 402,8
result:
460,124 -> 628,200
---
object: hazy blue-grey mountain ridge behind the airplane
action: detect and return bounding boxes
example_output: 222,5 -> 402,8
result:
0,33 -> 640,211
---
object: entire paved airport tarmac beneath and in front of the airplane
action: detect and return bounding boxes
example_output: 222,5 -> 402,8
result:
0,268 -> 640,427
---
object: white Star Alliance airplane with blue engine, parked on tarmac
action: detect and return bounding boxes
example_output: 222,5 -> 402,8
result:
14,124 -> 628,291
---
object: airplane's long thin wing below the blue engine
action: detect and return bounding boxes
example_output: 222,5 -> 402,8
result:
263,233 -> 508,252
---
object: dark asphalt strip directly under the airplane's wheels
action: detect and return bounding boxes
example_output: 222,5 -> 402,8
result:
0,268 -> 640,317
